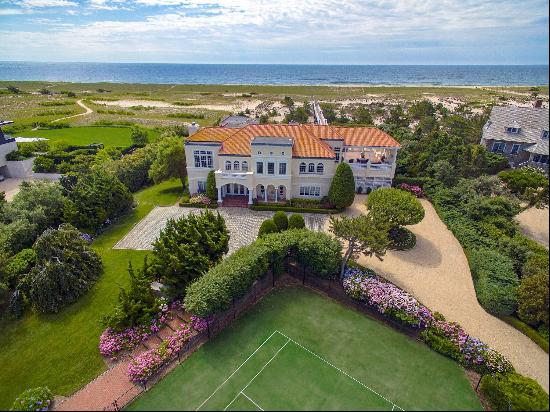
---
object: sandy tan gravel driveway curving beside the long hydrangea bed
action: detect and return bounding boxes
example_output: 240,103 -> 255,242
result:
340,196 -> 548,392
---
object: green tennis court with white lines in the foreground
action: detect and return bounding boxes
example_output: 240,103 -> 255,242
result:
128,287 -> 483,410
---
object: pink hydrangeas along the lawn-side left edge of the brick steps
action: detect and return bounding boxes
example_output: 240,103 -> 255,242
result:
99,301 -> 181,360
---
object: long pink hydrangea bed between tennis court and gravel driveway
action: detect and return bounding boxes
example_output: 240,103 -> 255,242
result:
343,268 -> 514,374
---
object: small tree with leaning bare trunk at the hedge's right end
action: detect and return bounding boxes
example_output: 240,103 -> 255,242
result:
330,214 -> 390,275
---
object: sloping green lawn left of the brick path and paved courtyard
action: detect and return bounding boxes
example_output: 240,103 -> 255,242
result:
0,180 -> 181,410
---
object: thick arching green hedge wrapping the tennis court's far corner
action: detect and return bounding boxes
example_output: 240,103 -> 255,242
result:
184,229 -> 342,317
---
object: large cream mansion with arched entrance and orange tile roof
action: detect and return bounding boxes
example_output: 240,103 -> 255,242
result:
185,124 -> 400,204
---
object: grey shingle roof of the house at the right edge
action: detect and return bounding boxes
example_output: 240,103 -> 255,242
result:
483,106 -> 548,154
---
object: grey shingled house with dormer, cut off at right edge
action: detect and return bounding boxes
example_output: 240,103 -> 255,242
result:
481,106 -> 548,171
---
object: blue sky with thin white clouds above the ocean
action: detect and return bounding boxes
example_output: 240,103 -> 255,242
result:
0,0 -> 549,64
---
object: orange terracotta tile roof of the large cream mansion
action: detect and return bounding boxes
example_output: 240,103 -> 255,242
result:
187,124 -> 399,158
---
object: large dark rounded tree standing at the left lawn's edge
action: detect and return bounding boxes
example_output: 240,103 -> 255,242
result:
24,224 -> 102,312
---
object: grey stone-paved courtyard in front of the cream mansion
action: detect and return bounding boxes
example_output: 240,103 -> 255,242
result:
114,206 -> 329,254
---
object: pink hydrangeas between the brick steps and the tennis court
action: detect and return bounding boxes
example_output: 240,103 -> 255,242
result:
128,324 -> 192,385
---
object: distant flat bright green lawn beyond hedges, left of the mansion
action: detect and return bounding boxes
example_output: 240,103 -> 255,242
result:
15,126 -> 159,147
